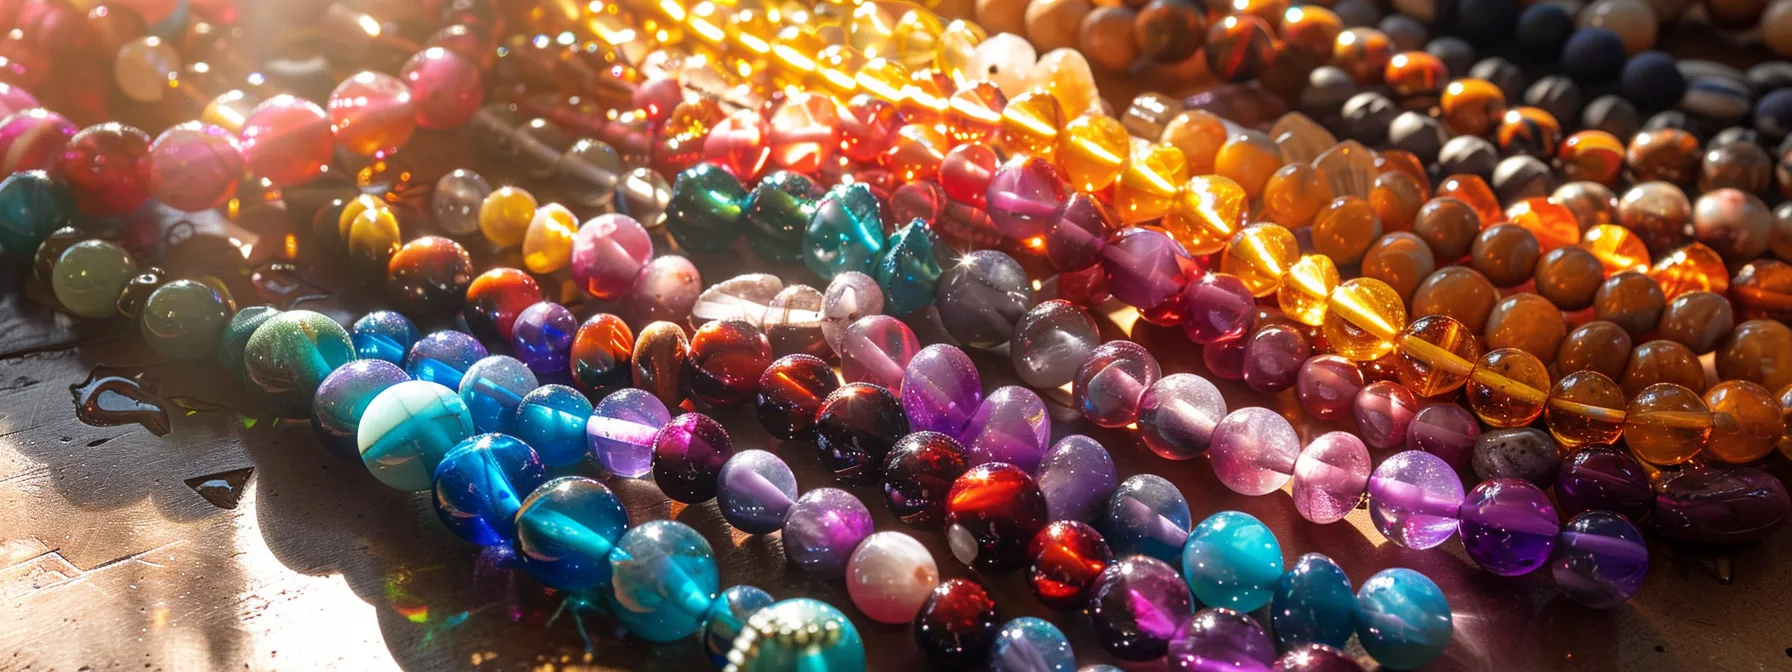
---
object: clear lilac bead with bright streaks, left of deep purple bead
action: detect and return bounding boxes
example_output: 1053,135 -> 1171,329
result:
1369,450 -> 1462,548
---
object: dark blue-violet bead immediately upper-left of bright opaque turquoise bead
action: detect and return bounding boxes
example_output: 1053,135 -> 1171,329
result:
1098,473 -> 1192,563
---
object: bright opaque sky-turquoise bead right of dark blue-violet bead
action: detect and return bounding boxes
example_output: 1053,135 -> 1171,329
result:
1183,511 -> 1281,611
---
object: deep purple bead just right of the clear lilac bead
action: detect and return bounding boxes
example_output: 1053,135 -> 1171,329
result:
1457,478 -> 1563,577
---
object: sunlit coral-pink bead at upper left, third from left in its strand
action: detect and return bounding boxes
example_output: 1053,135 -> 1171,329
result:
242,93 -> 335,186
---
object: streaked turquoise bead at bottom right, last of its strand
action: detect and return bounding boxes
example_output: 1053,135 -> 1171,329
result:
1357,568 -> 1455,670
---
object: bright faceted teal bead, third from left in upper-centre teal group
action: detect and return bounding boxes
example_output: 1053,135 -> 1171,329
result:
803,183 -> 883,280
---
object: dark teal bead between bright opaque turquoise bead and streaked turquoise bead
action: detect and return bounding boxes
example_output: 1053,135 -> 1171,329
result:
1269,554 -> 1357,649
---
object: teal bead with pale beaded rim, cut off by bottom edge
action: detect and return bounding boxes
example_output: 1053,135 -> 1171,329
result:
729,597 -> 866,672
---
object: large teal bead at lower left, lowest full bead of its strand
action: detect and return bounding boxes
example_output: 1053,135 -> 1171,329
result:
609,520 -> 720,643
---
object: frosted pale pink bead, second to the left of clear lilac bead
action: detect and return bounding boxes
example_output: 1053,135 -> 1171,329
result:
1210,407 -> 1301,496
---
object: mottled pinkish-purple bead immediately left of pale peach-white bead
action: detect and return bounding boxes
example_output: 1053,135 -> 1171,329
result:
783,487 -> 876,579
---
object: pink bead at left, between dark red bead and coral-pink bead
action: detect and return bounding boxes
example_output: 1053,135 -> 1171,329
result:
149,122 -> 244,211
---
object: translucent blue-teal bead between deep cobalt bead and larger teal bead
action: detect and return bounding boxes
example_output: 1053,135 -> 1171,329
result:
516,477 -> 630,590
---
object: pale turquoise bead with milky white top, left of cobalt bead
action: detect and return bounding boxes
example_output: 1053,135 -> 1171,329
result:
355,380 -> 473,493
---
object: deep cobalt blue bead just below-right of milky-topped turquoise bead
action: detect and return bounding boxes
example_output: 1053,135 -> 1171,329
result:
435,434 -> 548,547
